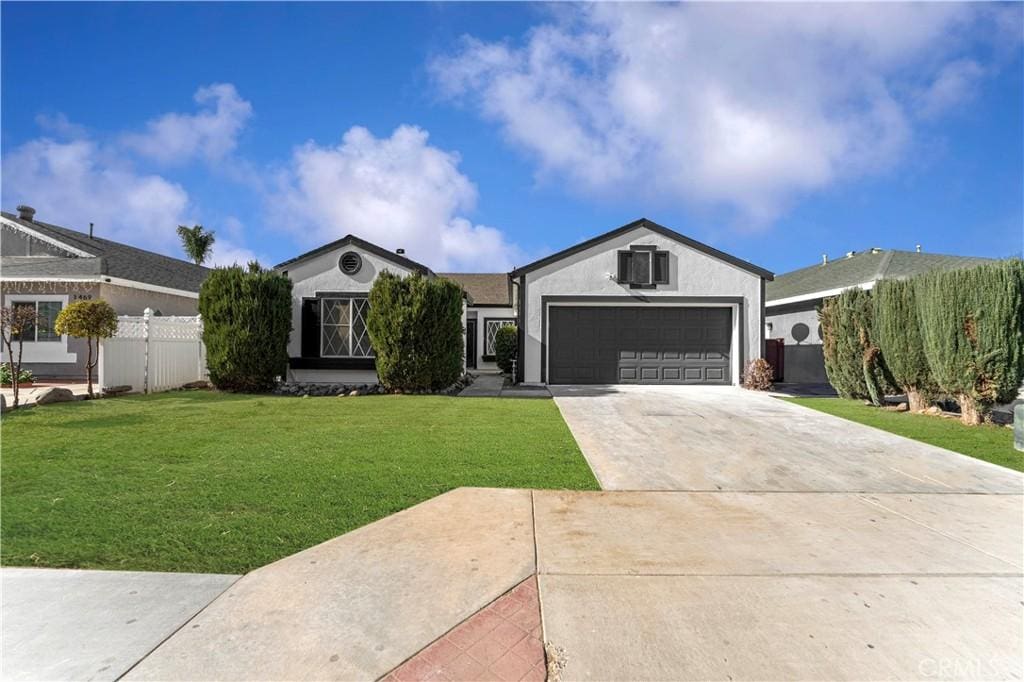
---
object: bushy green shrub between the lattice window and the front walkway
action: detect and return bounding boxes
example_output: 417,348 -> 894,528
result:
367,270 -> 465,391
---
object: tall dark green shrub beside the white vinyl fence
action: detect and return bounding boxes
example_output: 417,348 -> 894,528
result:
199,265 -> 292,391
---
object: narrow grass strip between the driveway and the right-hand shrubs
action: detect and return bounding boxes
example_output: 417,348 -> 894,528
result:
785,397 -> 1024,471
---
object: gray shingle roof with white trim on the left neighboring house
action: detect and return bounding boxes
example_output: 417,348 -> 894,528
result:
0,211 -> 210,292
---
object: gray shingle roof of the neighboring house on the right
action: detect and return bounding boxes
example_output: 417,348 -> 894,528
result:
765,249 -> 992,305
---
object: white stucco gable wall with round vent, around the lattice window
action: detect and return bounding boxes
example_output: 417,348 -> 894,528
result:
280,244 -> 412,358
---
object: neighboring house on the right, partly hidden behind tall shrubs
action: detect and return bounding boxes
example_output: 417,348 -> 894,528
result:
765,248 -> 992,384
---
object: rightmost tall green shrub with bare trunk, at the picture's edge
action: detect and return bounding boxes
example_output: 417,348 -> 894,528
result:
915,258 -> 1024,425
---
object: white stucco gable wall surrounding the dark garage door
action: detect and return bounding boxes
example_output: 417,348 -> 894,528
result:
523,226 -> 763,383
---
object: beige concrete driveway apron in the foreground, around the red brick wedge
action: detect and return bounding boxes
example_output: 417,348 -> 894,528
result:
103,488 -> 1024,680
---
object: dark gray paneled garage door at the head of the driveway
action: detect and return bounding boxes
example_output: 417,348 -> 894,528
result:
548,306 -> 732,384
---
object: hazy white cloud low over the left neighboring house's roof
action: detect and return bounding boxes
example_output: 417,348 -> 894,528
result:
2,137 -> 188,250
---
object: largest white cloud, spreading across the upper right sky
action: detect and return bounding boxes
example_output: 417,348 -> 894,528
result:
431,3 -> 1019,224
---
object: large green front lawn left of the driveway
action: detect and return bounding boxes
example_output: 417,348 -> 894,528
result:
0,391 -> 598,573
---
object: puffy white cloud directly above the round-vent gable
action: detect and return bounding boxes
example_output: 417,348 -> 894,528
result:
270,126 -> 521,270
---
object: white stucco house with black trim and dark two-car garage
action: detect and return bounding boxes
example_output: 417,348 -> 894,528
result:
274,220 -> 772,384
